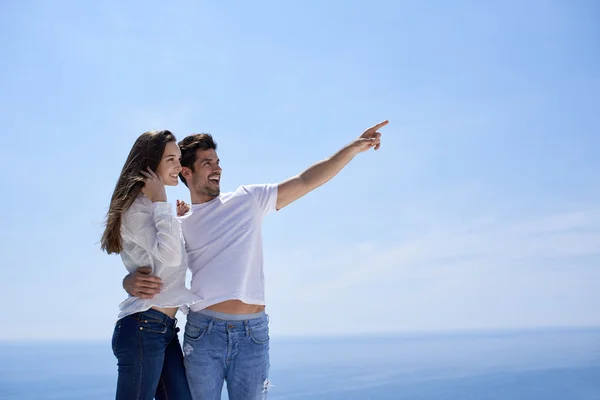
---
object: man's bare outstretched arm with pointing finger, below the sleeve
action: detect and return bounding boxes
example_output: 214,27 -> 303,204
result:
277,121 -> 388,210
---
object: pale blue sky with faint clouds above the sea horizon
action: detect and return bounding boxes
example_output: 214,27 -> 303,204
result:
0,0 -> 600,339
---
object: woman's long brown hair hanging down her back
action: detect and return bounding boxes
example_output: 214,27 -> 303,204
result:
101,130 -> 175,254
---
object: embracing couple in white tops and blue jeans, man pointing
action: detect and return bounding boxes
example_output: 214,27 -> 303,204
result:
101,121 -> 387,400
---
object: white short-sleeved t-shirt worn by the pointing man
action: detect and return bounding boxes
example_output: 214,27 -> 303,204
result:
180,184 -> 277,311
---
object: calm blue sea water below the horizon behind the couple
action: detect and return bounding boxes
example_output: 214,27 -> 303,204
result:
0,329 -> 600,400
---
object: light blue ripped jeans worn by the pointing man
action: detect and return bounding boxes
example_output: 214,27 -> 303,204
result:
183,310 -> 270,400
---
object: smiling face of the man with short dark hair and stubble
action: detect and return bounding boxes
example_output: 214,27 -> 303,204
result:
186,149 -> 221,198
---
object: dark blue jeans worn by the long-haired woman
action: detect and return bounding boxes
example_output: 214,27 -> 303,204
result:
112,309 -> 191,400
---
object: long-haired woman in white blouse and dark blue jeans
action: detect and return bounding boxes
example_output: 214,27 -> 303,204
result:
102,130 -> 198,400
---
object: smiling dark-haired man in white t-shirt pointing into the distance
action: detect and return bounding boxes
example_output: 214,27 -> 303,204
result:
123,121 -> 388,400
